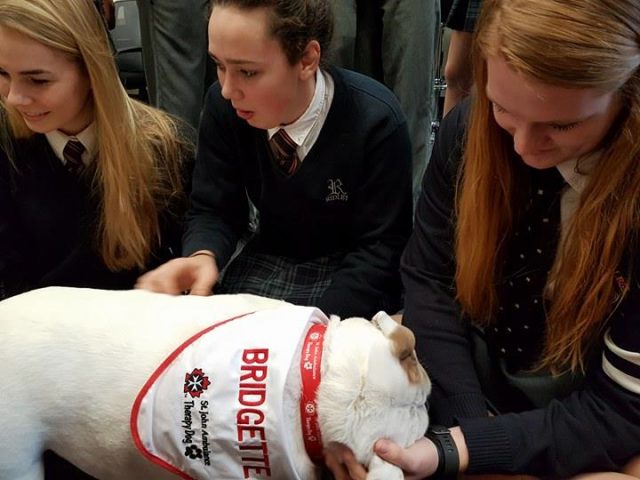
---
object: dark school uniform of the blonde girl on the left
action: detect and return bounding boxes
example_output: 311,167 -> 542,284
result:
0,124 -> 188,298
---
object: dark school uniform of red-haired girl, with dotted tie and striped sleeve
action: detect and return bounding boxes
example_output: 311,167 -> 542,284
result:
402,101 -> 640,478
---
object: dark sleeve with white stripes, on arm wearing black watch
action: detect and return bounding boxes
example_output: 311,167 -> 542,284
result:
460,276 -> 640,478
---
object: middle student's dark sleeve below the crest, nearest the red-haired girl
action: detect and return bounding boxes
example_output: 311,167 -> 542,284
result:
318,111 -> 412,318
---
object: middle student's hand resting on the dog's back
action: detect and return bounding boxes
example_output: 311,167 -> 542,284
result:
135,255 -> 218,295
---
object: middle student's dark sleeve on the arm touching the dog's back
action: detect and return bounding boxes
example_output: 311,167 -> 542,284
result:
182,83 -> 248,269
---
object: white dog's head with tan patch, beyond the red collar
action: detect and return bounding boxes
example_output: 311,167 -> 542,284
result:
318,312 -> 431,478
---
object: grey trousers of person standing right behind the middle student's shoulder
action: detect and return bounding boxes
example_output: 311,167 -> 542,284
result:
330,0 -> 440,201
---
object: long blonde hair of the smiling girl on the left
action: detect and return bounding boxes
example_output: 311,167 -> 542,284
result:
0,0 -> 192,271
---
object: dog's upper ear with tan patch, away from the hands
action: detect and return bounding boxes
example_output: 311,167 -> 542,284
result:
371,312 -> 426,383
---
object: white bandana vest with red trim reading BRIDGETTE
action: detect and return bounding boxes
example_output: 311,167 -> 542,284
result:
131,306 -> 328,480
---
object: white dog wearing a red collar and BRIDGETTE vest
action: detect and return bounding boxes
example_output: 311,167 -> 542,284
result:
0,287 -> 431,480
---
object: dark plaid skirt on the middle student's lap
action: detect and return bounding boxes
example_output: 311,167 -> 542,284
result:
215,245 -> 344,306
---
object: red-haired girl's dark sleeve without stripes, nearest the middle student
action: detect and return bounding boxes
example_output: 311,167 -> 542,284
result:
401,102 -> 487,425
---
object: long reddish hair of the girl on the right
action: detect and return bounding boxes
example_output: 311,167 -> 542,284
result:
455,0 -> 640,372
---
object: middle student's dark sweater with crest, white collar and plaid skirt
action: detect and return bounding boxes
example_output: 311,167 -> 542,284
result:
188,64 -> 412,316
